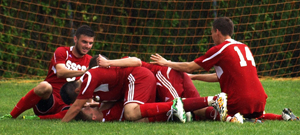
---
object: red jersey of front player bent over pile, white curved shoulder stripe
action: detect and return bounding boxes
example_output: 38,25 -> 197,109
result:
77,67 -> 133,102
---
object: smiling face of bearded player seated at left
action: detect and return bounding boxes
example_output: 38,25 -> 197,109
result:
74,35 -> 94,56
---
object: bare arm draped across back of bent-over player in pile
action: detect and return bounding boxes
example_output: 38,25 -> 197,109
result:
98,54 -> 142,67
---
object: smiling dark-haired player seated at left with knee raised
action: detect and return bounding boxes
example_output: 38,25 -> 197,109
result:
0,25 -> 94,119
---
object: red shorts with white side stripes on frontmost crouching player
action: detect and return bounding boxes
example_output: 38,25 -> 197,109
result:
124,67 -> 156,105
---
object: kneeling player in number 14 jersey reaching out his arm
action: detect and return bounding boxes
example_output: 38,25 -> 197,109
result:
150,17 -> 267,121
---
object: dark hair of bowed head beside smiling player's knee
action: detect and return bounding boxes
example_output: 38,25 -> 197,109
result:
60,81 -> 79,105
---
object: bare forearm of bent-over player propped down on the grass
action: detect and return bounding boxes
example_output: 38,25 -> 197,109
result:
61,99 -> 88,122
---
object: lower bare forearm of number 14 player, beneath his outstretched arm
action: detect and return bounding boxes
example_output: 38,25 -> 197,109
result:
188,73 -> 219,82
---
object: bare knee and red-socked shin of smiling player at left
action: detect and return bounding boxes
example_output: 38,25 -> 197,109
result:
10,81 -> 52,118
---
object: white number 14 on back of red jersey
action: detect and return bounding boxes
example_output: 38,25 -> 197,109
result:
234,46 -> 255,67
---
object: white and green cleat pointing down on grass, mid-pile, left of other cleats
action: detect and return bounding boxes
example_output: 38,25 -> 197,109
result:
167,97 -> 186,123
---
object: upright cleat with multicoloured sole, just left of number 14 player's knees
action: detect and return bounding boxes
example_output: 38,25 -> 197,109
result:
212,92 -> 227,121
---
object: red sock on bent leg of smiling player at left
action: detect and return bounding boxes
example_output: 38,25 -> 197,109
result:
10,89 -> 42,118
